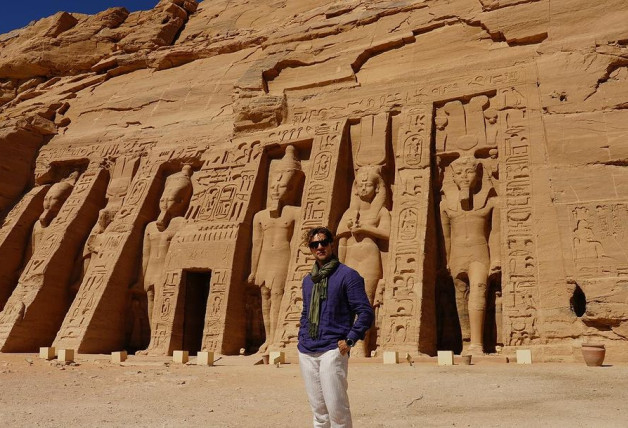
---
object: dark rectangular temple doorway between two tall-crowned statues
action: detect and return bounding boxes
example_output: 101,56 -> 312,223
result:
183,271 -> 211,355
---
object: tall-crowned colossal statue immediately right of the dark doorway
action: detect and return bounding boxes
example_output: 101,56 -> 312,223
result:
248,146 -> 303,352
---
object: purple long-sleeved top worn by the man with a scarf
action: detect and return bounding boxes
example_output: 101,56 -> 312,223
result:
297,263 -> 375,354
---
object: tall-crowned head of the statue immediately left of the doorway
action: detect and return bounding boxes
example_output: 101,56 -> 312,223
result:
156,165 -> 193,232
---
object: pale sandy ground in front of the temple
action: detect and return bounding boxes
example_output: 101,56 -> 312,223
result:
0,354 -> 628,427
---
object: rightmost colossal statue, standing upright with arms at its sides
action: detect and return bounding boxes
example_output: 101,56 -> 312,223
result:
440,155 -> 501,354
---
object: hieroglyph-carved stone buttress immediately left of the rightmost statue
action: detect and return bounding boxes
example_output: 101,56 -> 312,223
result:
380,108 -> 431,350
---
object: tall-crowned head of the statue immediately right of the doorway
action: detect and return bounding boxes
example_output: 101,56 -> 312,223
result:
268,146 -> 302,210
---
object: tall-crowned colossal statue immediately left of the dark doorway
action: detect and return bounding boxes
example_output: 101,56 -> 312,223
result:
141,165 -> 193,329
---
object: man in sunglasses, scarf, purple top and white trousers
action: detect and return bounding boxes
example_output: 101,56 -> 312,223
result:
298,227 -> 374,428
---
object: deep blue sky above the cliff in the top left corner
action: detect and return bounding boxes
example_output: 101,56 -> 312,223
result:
0,0 -> 204,34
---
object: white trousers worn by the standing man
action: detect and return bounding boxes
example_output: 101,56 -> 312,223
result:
299,348 -> 353,428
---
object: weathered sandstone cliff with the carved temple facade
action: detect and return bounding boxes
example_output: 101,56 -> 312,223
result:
0,0 -> 628,359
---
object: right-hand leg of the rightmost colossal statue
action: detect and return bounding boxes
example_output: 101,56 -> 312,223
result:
469,262 -> 488,354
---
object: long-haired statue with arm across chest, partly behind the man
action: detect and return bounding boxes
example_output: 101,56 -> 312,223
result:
337,165 -> 390,355
